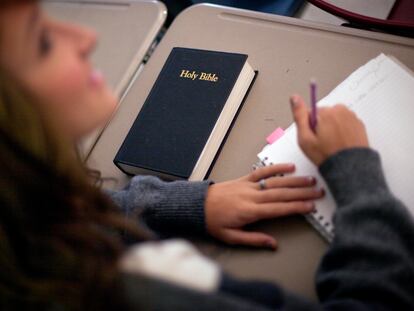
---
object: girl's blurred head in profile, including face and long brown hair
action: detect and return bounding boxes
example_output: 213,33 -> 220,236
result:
0,0 -> 149,310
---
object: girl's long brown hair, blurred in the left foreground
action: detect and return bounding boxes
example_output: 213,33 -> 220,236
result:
0,2 -> 149,310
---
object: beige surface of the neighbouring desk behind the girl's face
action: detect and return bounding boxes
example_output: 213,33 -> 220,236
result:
43,0 -> 167,155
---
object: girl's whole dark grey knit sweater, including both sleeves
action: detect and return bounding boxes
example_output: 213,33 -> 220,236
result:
105,148 -> 414,310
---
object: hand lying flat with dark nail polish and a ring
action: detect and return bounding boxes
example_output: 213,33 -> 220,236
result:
205,164 -> 323,249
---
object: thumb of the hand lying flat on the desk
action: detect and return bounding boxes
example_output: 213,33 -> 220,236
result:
223,229 -> 277,250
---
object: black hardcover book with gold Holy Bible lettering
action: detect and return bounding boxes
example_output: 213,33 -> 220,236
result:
114,47 -> 256,180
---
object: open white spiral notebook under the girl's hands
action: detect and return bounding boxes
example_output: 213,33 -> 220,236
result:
258,54 -> 414,241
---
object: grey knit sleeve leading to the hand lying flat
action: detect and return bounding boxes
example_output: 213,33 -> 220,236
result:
106,176 -> 211,234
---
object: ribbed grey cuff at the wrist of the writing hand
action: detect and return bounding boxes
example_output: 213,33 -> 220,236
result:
319,148 -> 388,207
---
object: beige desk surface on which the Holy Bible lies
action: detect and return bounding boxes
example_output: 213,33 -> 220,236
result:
89,5 -> 414,299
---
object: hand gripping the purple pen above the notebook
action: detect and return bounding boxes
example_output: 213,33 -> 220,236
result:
291,95 -> 368,166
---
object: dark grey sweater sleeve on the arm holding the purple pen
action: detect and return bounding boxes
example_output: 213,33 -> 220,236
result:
316,148 -> 414,310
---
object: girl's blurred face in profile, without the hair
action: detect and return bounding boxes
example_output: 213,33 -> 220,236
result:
0,0 -> 117,141
